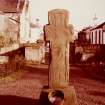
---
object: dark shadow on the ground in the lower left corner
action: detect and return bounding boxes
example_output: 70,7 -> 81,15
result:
0,95 -> 38,105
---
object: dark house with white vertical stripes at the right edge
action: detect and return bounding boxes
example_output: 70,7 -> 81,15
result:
78,22 -> 105,45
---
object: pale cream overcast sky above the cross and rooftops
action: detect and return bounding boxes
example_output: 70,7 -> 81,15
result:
30,0 -> 105,29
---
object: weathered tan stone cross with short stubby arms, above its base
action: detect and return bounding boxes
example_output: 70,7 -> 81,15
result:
45,9 -> 74,89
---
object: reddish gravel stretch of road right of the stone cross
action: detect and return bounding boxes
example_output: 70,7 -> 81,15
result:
70,67 -> 105,105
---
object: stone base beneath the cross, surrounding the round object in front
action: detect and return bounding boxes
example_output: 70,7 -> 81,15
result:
39,86 -> 77,105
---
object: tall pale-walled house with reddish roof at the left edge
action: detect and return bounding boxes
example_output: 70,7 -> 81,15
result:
0,0 -> 29,53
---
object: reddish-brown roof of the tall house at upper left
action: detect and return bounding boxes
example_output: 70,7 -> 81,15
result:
0,0 -> 25,13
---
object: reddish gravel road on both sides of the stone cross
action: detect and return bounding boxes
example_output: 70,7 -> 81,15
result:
0,66 -> 105,105
